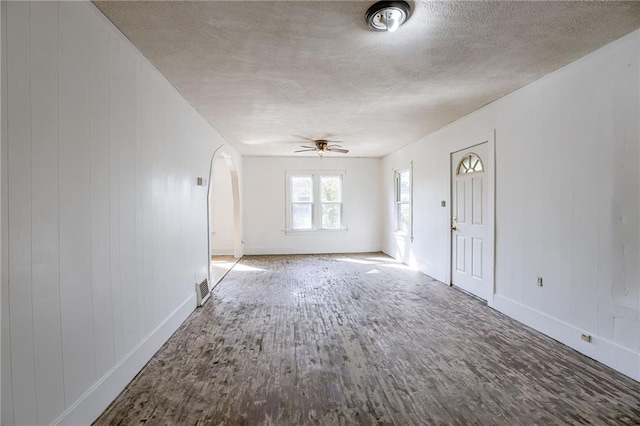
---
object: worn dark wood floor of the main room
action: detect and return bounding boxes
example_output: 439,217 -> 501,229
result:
96,254 -> 640,425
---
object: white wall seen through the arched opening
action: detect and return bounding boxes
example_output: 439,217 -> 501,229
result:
209,156 -> 234,255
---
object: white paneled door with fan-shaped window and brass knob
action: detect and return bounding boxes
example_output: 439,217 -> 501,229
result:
451,142 -> 493,300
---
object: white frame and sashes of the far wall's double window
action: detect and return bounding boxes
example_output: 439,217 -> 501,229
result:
284,170 -> 348,234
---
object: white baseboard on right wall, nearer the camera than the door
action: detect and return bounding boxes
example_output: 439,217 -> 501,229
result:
493,294 -> 640,381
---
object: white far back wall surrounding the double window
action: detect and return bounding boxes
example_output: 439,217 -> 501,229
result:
243,157 -> 382,254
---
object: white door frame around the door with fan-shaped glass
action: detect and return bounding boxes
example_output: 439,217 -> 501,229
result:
446,129 -> 496,306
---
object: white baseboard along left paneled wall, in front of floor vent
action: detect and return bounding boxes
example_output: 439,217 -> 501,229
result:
53,292 -> 196,425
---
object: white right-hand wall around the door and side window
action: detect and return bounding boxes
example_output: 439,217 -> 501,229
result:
382,32 -> 640,379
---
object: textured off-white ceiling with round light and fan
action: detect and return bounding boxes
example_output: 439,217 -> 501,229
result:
94,1 -> 640,157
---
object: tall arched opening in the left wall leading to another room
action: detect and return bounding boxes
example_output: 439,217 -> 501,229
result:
208,152 -> 242,287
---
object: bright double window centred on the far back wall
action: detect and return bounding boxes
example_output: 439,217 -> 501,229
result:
286,172 -> 345,231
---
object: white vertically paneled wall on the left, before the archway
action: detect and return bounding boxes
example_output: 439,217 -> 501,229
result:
2,2 -> 237,425
